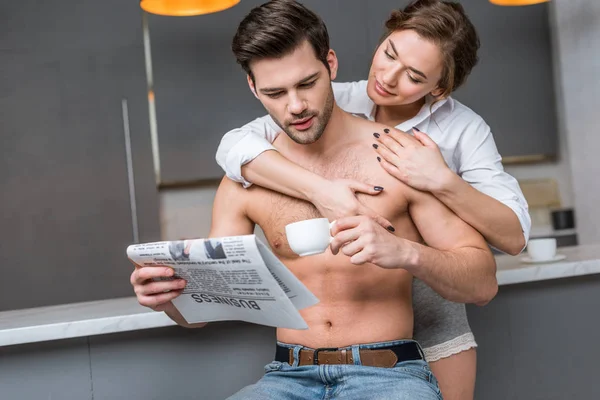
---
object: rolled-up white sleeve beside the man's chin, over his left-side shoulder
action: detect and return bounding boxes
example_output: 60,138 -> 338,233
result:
216,116 -> 279,188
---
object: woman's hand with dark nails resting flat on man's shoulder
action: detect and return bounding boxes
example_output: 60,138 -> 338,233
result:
373,128 -> 454,192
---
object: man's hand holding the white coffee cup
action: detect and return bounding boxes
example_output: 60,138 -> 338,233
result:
331,216 -> 416,269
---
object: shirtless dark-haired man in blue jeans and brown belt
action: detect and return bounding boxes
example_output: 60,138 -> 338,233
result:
131,0 -> 497,399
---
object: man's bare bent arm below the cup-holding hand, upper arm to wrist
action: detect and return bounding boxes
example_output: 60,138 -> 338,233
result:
403,190 -> 498,305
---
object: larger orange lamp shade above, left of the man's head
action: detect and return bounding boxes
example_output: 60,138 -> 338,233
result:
140,0 -> 240,17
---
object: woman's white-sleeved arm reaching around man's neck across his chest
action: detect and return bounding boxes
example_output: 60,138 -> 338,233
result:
217,81 -> 391,229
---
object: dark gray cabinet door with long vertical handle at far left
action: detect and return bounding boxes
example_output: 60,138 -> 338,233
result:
0,0 -> 160,310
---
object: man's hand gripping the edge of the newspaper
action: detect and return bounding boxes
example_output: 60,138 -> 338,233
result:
130,263 -> 186,312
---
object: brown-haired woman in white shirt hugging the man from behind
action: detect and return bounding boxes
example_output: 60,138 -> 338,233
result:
217,0 -> 530,400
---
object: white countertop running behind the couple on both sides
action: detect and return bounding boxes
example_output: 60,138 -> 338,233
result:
0,245 -> 600,346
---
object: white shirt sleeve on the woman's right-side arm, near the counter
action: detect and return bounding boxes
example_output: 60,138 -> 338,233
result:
457,118 -> 531,245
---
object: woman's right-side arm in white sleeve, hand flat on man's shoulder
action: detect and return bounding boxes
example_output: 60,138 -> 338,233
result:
377,121 -> 531,255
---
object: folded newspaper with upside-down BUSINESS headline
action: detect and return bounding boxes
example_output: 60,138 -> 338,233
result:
127,235 -> 319,329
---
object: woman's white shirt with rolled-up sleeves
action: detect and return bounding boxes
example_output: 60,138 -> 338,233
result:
217,81 -> 531,247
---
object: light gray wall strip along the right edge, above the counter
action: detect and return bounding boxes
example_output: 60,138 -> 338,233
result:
552,0 -> 600,244
